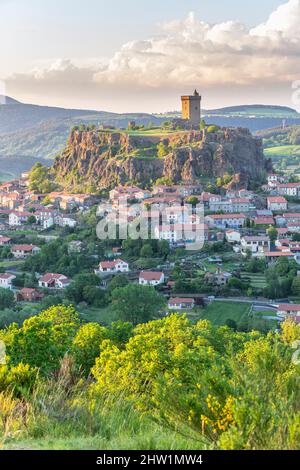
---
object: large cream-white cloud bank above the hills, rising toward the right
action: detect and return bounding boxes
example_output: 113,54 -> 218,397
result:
7,0 -> 300,110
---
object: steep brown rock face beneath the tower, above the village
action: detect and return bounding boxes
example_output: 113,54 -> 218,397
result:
54,128 -> 272,189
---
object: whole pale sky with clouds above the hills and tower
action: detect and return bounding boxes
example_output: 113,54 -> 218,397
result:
0,0 -> 300,112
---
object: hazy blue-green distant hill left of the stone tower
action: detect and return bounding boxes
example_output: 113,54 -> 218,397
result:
0,96 -> 164,174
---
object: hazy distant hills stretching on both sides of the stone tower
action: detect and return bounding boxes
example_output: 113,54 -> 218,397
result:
0,95 -> 300,174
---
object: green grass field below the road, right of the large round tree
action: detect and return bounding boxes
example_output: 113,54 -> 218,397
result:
201,300 -> 250,326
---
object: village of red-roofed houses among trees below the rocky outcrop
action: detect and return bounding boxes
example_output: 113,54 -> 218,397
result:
0,168 -> 300,329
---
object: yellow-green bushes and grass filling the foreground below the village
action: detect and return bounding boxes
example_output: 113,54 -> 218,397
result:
0,306 -> 300,450
